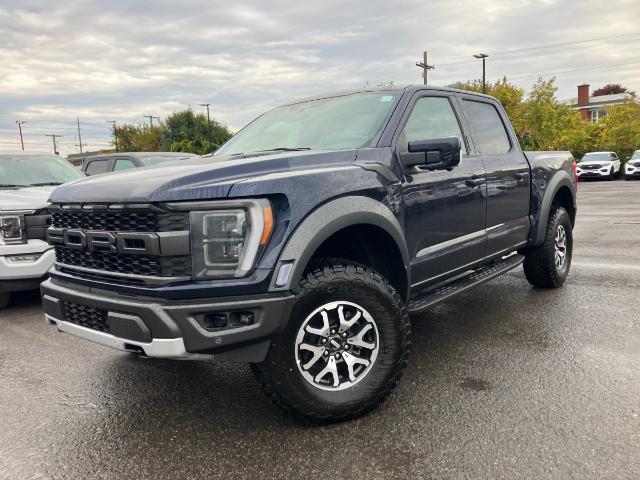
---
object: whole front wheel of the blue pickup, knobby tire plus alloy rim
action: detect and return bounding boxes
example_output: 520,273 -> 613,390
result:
252,259 -> 410,423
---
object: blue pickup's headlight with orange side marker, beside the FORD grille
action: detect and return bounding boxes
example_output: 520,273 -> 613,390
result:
190,200 -> 273,278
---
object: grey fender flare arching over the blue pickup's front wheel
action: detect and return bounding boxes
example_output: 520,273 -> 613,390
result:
269,196 -> 411,291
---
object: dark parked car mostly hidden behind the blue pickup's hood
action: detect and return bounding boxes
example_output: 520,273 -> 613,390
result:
82,152 -> 199,175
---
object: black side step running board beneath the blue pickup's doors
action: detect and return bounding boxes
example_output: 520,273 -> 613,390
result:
407,254 -> 524,313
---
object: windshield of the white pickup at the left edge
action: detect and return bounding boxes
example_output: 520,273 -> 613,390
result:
0,155 -> 84,188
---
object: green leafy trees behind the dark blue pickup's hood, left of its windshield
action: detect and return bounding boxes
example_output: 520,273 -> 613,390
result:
111,109 -> 232,155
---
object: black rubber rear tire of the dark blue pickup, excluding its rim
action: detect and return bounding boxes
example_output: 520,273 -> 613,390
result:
524,207 -> 573,288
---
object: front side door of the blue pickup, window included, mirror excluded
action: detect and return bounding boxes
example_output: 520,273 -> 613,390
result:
396,92 -> 487,287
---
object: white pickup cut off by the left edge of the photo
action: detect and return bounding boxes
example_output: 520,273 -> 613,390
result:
0,152 -> 84,308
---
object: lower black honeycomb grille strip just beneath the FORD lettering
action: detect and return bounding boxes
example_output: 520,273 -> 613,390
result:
55,247 -> 191,277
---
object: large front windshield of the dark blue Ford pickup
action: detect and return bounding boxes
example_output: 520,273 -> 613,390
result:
216,92 -> 399,155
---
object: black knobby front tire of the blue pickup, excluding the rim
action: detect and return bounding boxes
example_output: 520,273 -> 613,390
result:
252,258 -> 411,423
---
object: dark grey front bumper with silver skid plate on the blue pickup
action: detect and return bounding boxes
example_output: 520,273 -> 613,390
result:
41,279 -> 294,362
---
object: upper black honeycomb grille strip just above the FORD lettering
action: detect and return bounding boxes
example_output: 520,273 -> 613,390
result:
51,212 -> 189,232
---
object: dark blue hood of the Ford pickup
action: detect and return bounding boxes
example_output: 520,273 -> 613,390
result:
50,150 -> 357,203
